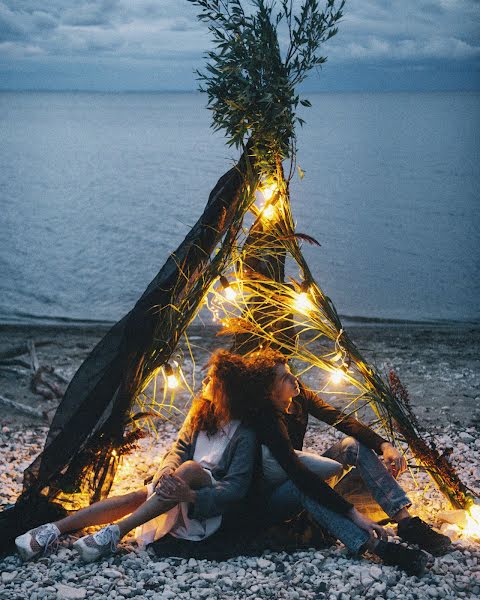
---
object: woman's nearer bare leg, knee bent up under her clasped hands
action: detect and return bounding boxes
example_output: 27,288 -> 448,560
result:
117,460 -> 211,538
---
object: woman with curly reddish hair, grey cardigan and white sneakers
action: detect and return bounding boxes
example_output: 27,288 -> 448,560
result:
15,350 -> 256,562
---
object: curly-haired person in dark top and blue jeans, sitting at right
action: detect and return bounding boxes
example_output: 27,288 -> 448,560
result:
249,350 -> 450,575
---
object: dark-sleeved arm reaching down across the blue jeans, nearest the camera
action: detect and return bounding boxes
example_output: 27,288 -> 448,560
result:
260,414 -> 353,514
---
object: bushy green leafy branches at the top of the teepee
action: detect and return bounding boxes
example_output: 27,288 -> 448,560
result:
188,0 -> 345,173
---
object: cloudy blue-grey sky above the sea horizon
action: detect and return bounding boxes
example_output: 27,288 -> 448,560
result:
0,0 -> 480,91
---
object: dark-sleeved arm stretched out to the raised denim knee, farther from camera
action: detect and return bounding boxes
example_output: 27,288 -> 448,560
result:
302,386 -> 389,454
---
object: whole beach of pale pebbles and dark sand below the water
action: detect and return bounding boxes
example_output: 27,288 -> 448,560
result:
0,325 -> 480,600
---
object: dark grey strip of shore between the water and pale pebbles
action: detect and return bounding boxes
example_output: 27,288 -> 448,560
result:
0,323 -> 480,426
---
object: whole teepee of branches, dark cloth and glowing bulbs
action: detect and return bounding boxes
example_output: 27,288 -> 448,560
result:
0,0 -> 471,552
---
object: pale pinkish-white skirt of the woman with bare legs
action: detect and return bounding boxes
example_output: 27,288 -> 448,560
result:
135,469 -> 222,548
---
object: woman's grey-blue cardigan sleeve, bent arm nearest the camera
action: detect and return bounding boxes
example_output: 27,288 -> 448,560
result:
189,428 -> 256,519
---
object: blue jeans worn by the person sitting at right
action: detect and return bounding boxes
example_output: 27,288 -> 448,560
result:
265,437 -> 411,554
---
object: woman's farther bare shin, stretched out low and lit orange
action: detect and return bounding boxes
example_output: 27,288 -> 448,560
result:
55,487 -> 147,533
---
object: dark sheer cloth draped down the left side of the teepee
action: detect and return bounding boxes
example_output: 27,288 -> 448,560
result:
0,145 -> 255,552
